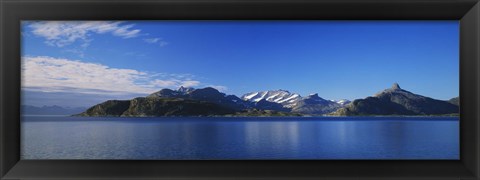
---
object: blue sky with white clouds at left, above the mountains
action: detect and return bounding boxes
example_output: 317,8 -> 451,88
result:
22,21 -> 459,107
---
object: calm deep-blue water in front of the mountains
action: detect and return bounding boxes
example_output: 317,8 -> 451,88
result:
21,116 -> 459,159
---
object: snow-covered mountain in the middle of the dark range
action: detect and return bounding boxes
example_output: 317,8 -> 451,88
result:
241,89 -> 302,108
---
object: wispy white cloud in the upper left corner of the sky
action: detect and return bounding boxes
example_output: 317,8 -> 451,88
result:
28,21 -> 140,47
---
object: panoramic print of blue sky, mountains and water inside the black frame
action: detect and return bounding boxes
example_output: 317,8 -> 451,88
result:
21,21 -> 460,160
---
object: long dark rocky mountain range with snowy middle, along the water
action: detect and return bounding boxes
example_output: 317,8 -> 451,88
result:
77,83 -> 459,117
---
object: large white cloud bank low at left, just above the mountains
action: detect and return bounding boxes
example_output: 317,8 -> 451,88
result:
22,56 -> 201,94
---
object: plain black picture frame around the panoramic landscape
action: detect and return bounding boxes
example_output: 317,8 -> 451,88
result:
0,0 -> 480,180
